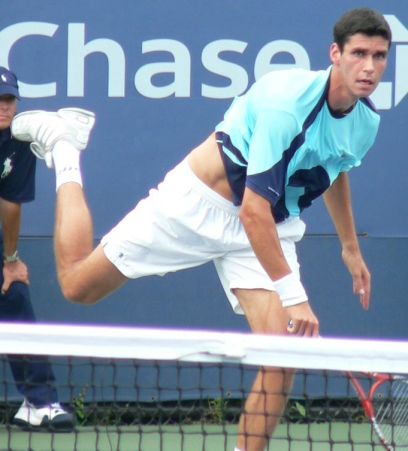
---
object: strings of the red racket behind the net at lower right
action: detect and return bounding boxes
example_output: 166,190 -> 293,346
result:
374,379 -> 408,449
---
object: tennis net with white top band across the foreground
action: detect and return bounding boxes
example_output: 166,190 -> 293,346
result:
0,324 -> 408,451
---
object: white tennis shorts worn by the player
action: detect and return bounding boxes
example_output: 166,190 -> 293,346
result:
102,160 -> 305,314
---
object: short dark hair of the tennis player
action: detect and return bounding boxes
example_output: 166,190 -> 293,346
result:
333,8 -> 392,51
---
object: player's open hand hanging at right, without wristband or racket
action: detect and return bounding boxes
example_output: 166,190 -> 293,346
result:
342,250 -> 371,310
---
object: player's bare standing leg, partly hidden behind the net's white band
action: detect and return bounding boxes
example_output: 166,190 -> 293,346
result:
234,290 -> 294,451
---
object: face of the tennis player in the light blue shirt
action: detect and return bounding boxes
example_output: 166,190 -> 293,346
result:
330,33 -> 388,99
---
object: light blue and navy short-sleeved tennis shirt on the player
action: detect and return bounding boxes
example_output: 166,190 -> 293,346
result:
215,67 -> 380,222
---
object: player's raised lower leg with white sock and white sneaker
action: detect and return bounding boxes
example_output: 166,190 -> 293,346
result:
12,108 -> 127,304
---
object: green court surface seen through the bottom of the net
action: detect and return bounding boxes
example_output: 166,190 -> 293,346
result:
0,423 -> 390,451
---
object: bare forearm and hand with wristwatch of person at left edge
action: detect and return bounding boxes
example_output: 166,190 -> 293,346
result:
0,198 -> 29,293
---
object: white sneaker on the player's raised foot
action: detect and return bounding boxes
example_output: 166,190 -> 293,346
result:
11,108 -> 95,168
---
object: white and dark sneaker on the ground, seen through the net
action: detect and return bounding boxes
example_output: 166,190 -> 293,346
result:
13,399 -> 74,432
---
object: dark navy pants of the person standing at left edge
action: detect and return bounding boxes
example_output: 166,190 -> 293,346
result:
0,280 -> 57,407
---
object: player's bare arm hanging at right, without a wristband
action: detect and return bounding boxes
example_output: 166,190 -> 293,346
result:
323,172 -> 371,310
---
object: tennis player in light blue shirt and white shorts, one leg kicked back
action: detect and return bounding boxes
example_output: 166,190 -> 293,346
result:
12,8 -> 391,451
